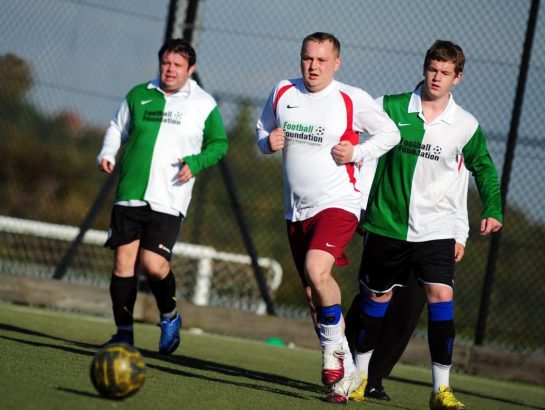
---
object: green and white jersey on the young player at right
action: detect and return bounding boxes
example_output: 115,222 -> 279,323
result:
364,88 -> 503,242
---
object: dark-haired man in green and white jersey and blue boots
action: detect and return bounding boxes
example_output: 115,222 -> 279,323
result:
97,39 -> 228,354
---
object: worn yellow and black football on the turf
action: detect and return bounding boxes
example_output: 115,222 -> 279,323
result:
91,343 -> 146,399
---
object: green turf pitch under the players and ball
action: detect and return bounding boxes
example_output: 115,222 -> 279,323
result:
0,302 -> 545,410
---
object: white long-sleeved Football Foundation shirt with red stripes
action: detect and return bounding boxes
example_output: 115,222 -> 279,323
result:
256,78 -> 400,221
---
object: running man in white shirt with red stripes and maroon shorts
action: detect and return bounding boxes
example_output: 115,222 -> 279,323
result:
256,32 -> 400,404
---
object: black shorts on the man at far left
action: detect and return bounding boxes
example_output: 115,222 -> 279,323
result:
104,205 -> 183,261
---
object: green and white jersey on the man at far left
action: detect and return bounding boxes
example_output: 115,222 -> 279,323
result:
98,80 -> 228,216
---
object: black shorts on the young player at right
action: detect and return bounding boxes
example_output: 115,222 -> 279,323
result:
359,232 -> 456,293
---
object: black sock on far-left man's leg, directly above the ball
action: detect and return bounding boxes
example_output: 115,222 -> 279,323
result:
110,274 -> 136,327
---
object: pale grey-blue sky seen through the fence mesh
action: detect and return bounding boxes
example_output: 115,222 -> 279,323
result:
0,0 -> 545,220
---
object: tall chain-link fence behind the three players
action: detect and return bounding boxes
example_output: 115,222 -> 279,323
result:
0,0 -> 545,355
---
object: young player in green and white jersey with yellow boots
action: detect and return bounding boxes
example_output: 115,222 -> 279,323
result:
336,40 -> 502,409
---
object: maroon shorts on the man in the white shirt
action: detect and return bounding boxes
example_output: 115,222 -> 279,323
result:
287,208 -> 358,286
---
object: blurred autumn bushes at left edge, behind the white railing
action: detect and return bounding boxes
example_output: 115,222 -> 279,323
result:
0,54 -> 109,225
